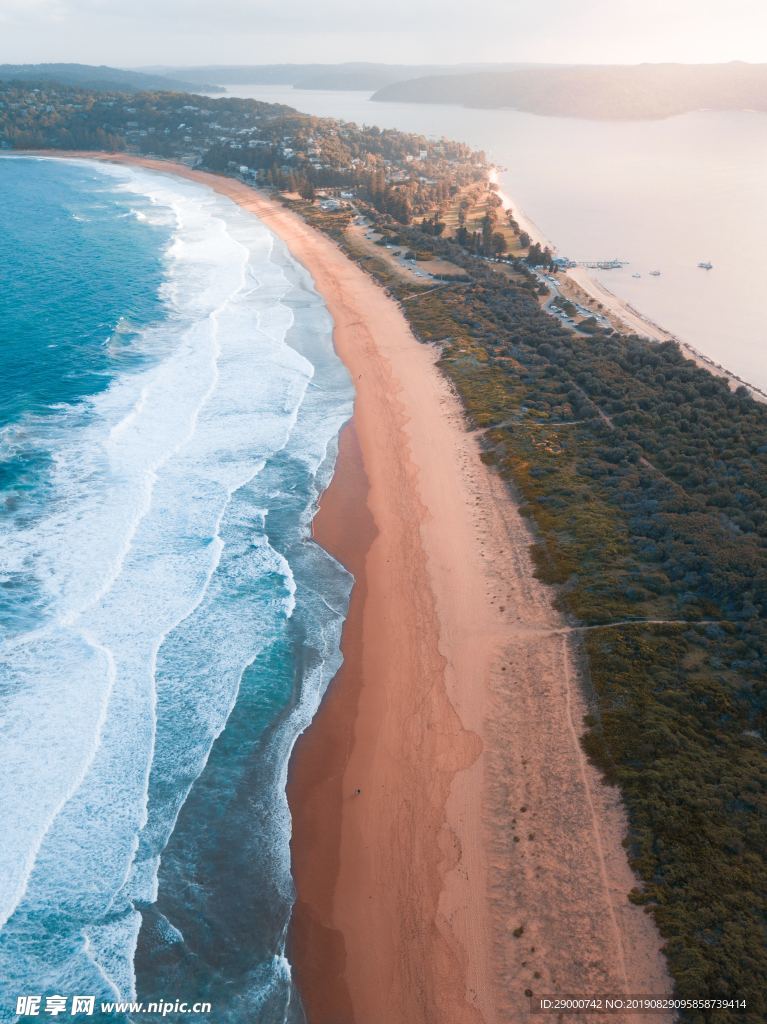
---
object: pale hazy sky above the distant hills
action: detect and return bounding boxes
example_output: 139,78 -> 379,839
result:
0,0 -> 767,68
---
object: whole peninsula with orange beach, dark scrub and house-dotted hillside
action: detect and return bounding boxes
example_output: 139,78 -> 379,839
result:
0,75 -> 767,1024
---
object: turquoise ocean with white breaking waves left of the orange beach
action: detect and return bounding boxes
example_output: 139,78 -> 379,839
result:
0,158 -> 353,1024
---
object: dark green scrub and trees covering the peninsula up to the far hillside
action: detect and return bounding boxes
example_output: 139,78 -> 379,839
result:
0,85 -> 767,1024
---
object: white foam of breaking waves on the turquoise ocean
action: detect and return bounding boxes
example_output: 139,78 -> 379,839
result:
0,159 -> 348,996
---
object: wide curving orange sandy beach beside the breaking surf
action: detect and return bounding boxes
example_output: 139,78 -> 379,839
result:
56,154 -> 671,1024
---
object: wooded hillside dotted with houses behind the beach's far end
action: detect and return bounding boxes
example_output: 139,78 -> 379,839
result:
0,82 -> 487,223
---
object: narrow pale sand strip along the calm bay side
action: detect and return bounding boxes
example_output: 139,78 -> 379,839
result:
488,169 -> 767,402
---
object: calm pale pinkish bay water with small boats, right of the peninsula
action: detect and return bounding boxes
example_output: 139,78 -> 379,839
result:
215,86 -> 767,389
